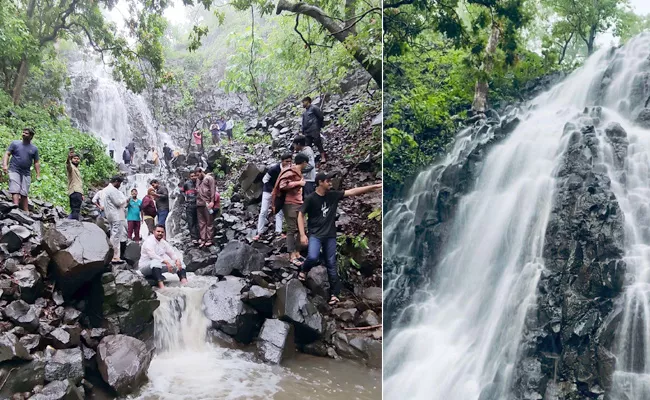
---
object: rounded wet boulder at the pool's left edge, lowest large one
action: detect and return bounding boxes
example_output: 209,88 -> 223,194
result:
97,335 -> 152,396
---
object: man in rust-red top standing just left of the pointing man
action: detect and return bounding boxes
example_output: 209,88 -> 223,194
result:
271,153 -> 308,266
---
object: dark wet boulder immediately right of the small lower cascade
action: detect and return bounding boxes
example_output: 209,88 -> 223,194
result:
203,276 -> 260,343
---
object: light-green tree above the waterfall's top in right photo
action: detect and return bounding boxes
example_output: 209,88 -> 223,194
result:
545,0 -> 629,56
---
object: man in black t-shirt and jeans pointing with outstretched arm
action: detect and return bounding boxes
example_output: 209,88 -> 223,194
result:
298,173 -> 382,306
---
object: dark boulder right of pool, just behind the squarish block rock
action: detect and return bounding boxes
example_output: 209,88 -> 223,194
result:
273,279 -> 324,343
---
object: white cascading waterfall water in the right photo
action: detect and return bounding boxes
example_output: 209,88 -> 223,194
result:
384,35 -> 650,400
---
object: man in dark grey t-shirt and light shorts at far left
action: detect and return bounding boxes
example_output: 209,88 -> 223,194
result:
2,128 -> 41,212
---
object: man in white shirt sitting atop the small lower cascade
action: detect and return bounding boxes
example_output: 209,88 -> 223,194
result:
140,225 -> 187,289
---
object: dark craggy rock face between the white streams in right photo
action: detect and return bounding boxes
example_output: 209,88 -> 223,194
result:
515,108 -> 627,399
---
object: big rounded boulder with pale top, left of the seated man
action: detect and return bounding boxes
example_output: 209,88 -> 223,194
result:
43,220 -> 113,296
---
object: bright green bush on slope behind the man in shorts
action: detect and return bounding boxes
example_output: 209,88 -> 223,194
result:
0,92 -> 117,207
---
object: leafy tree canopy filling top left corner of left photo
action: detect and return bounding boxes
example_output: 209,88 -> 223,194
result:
0,0 -> 167,103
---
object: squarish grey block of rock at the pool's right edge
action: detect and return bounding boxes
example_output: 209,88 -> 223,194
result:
257,319 -> 294,364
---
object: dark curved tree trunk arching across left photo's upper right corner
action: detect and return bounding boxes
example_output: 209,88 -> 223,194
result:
275,0 -> 382,87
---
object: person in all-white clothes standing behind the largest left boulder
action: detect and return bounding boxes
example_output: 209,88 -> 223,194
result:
104,176 -> 129,262
